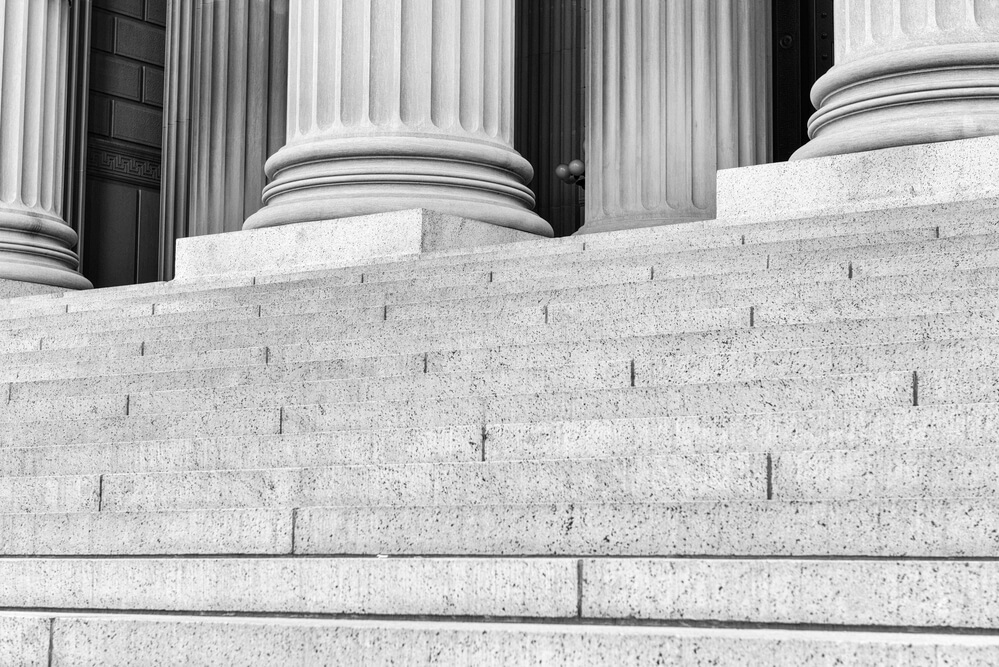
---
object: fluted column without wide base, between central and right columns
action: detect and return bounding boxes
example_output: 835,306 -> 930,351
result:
580,0 -> 770,233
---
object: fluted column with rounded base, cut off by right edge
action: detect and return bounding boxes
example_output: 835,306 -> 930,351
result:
792,0 -> 999,159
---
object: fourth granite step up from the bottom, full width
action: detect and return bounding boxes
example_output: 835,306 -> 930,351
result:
60,447 -> 999,512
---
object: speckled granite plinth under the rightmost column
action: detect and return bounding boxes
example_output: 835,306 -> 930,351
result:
718,136 -> 999,222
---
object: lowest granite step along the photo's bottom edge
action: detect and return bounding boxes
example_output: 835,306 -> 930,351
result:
11,614 -> 999,667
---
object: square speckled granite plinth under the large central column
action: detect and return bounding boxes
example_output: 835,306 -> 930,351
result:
175,209 -> 544,280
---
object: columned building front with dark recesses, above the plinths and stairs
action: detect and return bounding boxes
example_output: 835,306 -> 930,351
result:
0,0 -> 984,291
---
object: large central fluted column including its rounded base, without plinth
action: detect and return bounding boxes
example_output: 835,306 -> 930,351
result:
243,0 -> 552,236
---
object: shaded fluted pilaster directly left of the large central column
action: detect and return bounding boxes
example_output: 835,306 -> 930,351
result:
160,0 -> 288,279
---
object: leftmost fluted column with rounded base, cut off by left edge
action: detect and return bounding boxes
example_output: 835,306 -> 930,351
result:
0,0 -> 92,289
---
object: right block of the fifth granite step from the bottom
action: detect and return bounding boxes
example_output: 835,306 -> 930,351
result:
485,403 -> 999,461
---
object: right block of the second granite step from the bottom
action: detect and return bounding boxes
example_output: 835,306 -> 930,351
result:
582,559 -> 999,628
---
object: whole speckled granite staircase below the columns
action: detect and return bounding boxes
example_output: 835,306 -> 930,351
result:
0,205 -> 999,667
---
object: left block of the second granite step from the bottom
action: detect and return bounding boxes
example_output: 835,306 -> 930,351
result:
0,558 -> 577,618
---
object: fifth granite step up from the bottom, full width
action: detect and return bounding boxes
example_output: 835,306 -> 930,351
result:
7,403 -> 999,476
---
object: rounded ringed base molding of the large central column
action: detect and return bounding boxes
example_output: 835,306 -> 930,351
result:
243,136 -> 553,236
